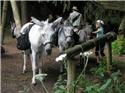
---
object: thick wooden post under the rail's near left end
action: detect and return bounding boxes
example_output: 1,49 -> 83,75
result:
67,59 -> 76,93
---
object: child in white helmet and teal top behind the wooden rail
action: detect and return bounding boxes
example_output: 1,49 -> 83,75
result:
93,20 -> 105,62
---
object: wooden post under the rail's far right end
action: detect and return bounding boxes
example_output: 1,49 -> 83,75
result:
106,40 -> 112,73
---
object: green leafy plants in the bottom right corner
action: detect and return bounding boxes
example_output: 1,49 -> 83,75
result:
85,71 -> 125,93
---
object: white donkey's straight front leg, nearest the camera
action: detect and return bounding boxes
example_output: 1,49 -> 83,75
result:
32,50 -> 36,84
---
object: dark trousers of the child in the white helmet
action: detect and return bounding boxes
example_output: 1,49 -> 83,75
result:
95,41 -> 105,56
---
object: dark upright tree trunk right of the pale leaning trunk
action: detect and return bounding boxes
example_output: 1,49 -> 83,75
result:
21,1 -> 27,25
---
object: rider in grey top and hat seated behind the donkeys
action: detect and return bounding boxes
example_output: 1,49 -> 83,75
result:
68,6 -> 83,33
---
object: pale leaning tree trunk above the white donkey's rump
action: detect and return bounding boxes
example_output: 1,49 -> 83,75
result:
10,0 -> 21,37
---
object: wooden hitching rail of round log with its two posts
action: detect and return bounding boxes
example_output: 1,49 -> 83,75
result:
64,32 -> 117,93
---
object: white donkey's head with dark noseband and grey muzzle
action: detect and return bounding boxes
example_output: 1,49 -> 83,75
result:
42,18 -> 61,54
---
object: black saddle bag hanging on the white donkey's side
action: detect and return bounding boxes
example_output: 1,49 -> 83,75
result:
17,25 -> 33,50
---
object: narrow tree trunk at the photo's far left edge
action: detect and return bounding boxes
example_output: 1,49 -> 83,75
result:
0,1 -> 8,44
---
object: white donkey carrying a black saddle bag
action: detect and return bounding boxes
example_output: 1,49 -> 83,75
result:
10,17 -> 62,84
